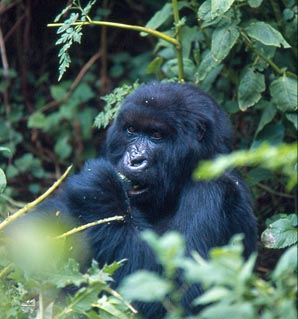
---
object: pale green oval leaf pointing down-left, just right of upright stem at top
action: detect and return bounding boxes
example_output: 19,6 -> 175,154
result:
211,25 -> 240,63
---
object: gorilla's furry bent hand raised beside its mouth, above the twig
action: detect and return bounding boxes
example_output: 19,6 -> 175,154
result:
61,159 -> 129,221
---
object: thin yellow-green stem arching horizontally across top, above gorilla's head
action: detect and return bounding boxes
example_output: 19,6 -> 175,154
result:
48,20 -> 180,46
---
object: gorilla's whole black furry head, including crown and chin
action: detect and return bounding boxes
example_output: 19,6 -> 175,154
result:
107,82 -> 231,216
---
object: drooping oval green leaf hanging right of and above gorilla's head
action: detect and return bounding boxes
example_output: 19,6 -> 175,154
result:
238,68 -> 265,111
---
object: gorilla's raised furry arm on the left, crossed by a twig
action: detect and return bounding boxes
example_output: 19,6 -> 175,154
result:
56,159 -> 159,276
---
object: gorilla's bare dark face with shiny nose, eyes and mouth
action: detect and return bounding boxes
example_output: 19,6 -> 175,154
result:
117,112 -> 173,198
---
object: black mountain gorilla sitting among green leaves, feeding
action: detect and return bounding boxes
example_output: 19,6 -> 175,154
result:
11,82 -> 256,319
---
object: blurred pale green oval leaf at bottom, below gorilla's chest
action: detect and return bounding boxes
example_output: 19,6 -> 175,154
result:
119,270 -> 170,302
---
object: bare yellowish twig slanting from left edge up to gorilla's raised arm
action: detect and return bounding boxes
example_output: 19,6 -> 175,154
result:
0,165 -> 72,230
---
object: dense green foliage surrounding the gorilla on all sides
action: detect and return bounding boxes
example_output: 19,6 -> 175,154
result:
0,0 -> 298,319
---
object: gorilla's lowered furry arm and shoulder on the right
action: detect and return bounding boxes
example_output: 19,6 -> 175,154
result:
172,171 -> 257,258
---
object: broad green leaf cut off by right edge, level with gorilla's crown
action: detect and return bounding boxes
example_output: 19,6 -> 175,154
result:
270,76 -> 297,112
